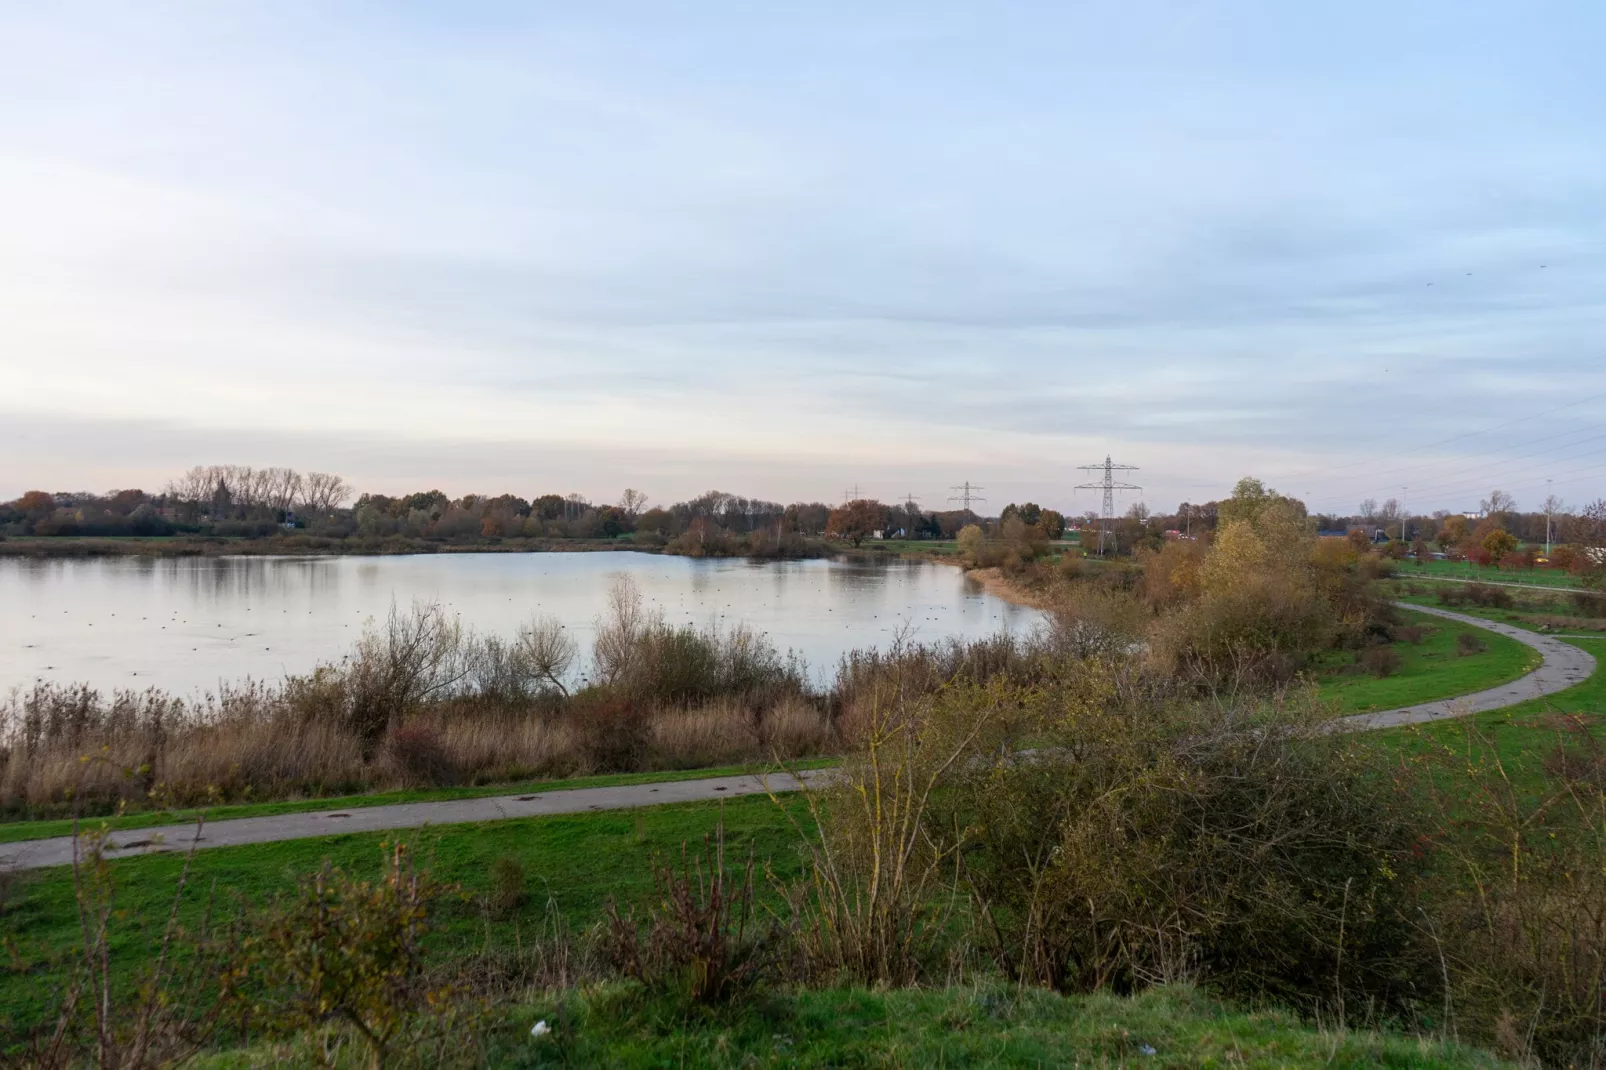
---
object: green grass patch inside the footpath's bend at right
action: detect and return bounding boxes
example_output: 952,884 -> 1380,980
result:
1315,612 -> 1540,713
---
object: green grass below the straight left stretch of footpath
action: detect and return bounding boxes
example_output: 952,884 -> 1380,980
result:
0,795 -> 806,1036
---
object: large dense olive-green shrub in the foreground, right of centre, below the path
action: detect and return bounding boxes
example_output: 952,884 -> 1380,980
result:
930,674 -> 1420,1007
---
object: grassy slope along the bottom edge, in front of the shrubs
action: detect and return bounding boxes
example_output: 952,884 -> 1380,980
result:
201,985 -> 1502,1070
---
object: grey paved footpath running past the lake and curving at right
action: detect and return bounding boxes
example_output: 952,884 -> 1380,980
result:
0,602 -> 1595,869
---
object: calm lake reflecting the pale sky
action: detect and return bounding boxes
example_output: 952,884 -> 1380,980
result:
0,553 -> 1041,696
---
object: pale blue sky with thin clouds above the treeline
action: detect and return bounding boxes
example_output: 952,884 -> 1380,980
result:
0,0 -> 1606,513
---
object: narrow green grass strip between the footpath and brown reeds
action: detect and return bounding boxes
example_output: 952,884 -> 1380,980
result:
0,748 -> 837,843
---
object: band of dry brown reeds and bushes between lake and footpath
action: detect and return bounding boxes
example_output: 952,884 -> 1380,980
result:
0,582 -> 1053,816
